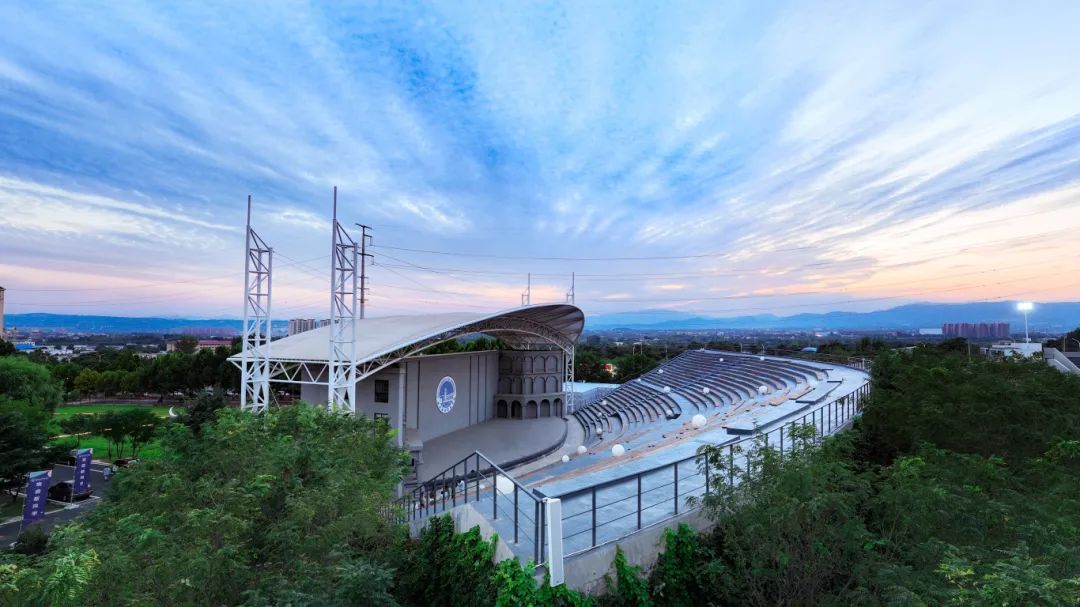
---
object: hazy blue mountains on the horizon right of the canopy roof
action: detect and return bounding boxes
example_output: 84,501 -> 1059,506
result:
585,301 -> 1080,332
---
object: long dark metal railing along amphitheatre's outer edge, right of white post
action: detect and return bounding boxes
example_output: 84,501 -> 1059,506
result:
552,383 -> 869,556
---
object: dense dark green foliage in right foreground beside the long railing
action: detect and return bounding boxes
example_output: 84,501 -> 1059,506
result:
678,346 -> 1080,606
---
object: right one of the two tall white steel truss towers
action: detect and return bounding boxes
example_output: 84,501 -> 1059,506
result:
326,186 -> 360,415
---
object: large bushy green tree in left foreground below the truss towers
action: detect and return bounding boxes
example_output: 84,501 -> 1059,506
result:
14,405 -> 406,606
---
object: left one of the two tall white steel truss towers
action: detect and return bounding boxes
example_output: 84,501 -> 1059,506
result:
240,195 -> 273,413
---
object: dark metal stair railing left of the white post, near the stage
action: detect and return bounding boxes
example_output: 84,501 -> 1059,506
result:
392,451 -> 545,564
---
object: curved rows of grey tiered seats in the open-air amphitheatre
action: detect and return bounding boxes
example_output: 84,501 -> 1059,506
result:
573,350 -> 826,444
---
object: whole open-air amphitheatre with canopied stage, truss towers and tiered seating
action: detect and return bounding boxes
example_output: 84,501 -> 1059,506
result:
231,198 -> 868,588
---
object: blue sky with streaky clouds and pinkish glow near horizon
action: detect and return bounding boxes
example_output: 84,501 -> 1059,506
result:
0,0 -> 1080,319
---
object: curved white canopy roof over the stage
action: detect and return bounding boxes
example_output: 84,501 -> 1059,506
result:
241,304 -> 585,364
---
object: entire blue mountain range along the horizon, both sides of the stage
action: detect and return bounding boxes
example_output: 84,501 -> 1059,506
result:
6,301 -> 1080,335
